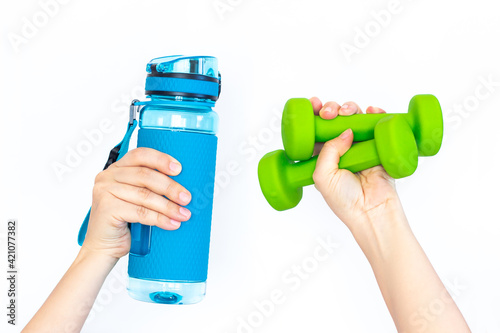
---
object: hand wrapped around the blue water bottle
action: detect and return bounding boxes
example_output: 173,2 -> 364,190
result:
83,148 -> 191,259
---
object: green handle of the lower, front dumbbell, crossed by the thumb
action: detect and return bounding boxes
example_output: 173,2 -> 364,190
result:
285,139 -> 380,187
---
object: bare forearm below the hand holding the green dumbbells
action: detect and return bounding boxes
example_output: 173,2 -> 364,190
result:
353,207 -> 470,333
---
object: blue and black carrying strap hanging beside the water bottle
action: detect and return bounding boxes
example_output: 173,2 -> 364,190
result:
78,99 -> 141,246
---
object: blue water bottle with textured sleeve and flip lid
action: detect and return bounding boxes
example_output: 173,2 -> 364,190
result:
79,56 -> 220,304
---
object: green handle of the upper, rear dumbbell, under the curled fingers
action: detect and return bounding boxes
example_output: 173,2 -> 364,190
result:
314,113 -> 394,142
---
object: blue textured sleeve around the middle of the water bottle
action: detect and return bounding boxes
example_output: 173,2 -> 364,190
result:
128,128 -> 217,281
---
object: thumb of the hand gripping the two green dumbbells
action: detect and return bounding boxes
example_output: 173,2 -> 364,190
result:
313,128 -> 353,179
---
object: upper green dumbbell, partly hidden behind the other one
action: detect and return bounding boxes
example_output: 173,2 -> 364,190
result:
281,95 -> 443,161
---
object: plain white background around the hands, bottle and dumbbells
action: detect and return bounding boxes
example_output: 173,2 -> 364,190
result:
0,0 -> 500,333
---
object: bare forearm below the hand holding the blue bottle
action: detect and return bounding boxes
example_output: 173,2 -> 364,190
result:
23,247 -> 117,333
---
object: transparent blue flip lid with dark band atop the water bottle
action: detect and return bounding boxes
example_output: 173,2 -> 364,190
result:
146,55 -> 221,104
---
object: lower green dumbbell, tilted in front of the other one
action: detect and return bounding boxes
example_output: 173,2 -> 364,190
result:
258,115 -> 418,211
